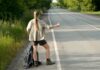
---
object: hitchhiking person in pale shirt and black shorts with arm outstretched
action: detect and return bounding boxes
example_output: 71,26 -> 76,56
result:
27,11 -> 59,67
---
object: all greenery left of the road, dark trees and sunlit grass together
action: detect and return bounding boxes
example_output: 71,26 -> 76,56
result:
0,0 -> 51,70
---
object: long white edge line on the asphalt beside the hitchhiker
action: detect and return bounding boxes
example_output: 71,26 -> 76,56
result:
48,16 -> 62,70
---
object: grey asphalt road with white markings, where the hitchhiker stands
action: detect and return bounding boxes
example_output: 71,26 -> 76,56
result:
8,9 -> 100,70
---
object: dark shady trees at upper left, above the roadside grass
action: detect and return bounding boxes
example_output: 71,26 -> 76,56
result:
0,0 -> 51,19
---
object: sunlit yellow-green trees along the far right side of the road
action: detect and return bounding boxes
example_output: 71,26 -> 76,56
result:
59,0 -> 100,11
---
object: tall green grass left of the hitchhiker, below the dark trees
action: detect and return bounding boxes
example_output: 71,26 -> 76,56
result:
0,20 -> 26,70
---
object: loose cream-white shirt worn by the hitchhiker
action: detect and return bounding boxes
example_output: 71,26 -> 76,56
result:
26,19 -> 49,41
